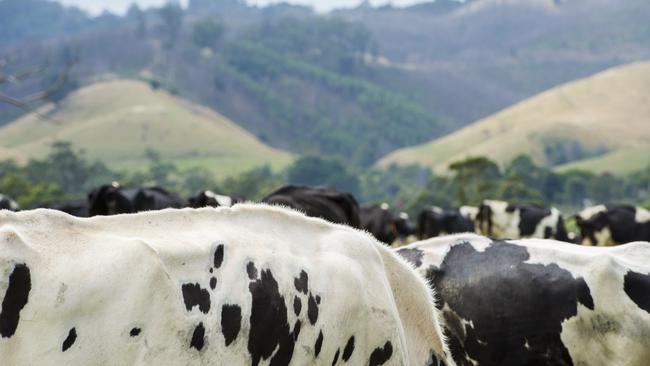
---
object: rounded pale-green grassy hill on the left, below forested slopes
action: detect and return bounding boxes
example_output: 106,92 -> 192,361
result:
0,80 -> 291,176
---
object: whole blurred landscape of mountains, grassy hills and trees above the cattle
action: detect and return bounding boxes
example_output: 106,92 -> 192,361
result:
0,0 -> 650,212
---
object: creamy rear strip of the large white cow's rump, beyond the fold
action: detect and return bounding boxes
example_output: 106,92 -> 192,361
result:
380,247 -> 454,366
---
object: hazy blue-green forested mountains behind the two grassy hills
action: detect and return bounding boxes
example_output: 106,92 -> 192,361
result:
0,0 -> 650,167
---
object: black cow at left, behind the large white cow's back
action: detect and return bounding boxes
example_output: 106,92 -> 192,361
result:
88,183 -> 184,216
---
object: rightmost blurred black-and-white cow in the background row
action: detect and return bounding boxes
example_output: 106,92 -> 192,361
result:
575,204 -> 650,246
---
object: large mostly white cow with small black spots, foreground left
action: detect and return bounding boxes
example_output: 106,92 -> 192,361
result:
0,204 -> 454,366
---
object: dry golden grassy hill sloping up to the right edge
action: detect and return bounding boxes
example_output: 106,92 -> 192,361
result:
378,62 -> 650,173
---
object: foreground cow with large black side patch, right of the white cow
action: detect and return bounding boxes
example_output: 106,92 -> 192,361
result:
397,234 -> 650,366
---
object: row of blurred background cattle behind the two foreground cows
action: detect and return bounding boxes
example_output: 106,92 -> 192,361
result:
0,183 -> 650,246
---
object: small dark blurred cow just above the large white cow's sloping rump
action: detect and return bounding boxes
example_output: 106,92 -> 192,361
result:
359,203 -> 415,245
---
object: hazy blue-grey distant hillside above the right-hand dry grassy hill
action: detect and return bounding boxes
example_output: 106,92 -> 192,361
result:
337,0 -> 650,127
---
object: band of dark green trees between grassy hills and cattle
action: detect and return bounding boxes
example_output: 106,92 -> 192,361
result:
0,142 -> 650,214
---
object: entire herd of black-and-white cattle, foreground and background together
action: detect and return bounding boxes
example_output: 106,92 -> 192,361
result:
0,184 -> 650,366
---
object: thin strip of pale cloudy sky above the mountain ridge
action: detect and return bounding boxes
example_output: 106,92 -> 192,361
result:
59,0 -> 423,14
